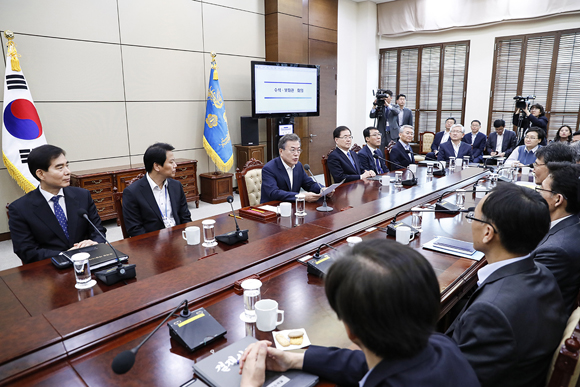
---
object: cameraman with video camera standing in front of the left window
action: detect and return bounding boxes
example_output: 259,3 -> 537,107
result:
369,90 -> 401,154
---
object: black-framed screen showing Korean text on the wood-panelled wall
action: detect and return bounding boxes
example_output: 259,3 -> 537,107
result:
252,61 -> 320,118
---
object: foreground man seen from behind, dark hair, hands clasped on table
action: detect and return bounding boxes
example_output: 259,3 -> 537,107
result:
240,239 -> 479,387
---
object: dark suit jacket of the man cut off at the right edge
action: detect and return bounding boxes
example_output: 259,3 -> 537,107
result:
531,215 -> 580,315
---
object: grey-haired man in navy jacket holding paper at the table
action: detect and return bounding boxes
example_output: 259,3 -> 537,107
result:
260,133 -> 320,203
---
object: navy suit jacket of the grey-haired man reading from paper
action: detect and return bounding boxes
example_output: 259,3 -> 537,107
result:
260,157 -> 320,203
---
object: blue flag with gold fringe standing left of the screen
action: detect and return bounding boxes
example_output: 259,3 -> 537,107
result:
203,57 -> 234,172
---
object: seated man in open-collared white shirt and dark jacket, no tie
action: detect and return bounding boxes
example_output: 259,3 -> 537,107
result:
123,142 -> 191,236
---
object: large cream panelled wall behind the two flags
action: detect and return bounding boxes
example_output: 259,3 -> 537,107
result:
0,0 -> 266,233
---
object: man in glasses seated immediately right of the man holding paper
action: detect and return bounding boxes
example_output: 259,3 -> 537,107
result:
327,126 -> 376,183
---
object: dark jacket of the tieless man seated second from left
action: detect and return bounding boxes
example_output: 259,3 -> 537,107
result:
123,177 -> 191,236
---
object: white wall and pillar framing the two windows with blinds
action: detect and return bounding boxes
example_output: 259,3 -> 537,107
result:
337,0 -> 580,138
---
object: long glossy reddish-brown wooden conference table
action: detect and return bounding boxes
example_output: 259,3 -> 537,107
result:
0,167 -> 488,386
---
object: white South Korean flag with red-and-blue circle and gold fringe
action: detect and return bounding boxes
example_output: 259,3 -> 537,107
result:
2,31 -> 46,192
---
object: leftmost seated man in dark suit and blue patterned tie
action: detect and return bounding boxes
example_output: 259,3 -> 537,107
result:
8,145 -> 106,264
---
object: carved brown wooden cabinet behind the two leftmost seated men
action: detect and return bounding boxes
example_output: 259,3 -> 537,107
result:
71,159 -> 199,220
